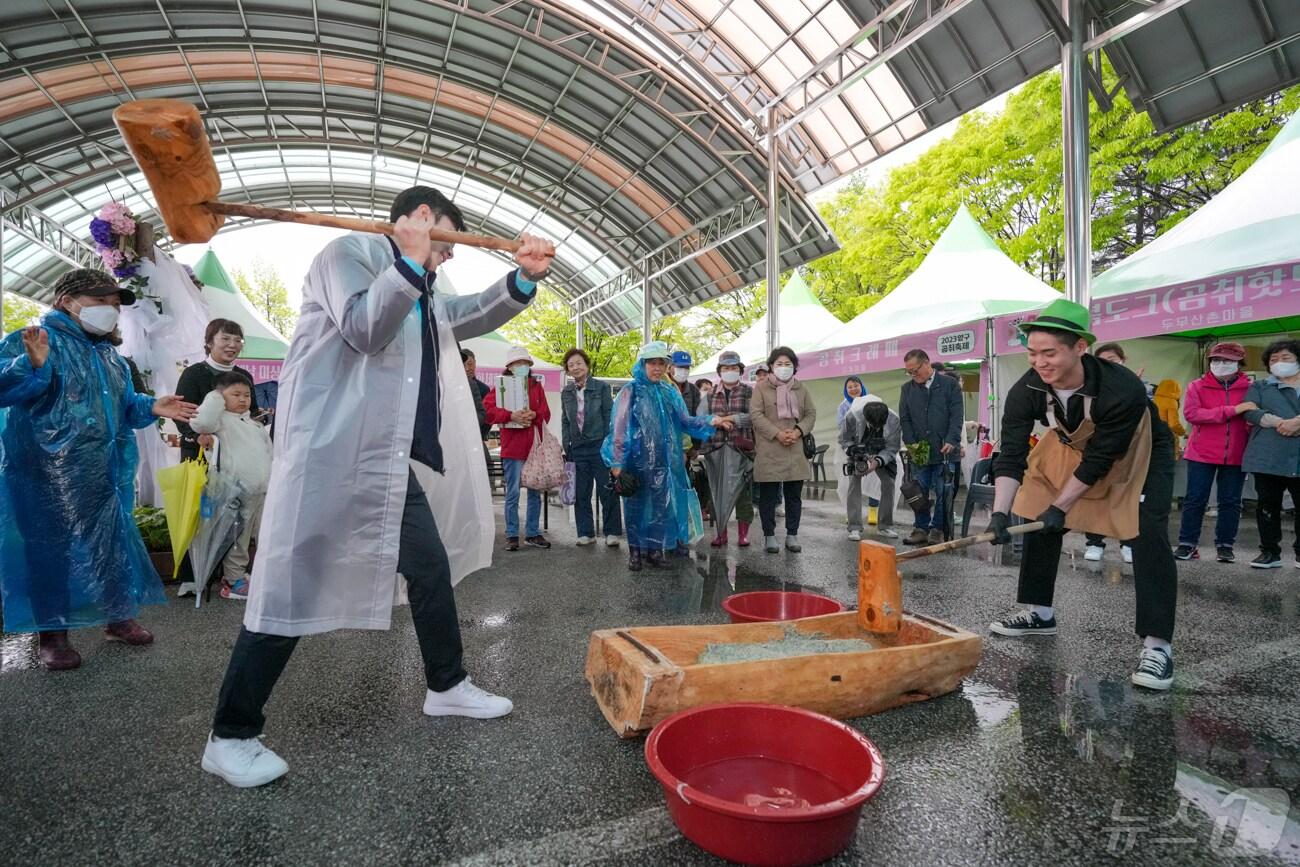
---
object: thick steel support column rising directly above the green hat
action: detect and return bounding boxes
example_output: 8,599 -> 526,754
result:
1061,0 -> 1092,307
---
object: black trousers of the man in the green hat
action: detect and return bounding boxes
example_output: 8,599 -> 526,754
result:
1017,450 -> 1178,641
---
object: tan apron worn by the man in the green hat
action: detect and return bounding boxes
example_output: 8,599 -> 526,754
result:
1011,395 -> 1151,541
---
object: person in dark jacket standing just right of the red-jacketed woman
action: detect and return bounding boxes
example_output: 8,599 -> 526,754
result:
560,348 -> 623,547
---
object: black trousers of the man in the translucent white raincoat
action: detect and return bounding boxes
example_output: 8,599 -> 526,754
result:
212,472 -> 465,738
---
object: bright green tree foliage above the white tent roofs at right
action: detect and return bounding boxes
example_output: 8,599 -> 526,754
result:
807,69 -> 1300,320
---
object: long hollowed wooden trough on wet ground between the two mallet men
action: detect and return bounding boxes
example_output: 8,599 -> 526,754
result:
586,611 -> 980,737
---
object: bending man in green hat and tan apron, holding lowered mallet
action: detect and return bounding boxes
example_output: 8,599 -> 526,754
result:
989,299 -> 1178,690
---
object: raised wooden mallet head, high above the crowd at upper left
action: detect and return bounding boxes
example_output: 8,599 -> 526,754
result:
113,99 -> 226,244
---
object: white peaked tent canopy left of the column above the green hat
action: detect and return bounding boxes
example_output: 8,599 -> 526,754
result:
818,205 -> 1061,348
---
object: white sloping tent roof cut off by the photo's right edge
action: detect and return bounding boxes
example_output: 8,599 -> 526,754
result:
1092,114 -> 1300,337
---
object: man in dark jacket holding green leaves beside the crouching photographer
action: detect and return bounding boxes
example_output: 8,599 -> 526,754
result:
898,350 -> 965,545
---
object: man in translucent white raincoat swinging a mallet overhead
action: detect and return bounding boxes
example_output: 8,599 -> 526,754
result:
203,187 -> 555,786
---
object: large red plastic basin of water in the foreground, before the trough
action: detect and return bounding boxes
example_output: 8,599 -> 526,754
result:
646,703 -> 885,867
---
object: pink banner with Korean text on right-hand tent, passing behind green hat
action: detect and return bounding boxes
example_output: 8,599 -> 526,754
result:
995,263 -> 1300,355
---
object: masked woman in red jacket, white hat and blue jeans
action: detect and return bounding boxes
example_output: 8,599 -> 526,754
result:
484,346 -> 551,551
